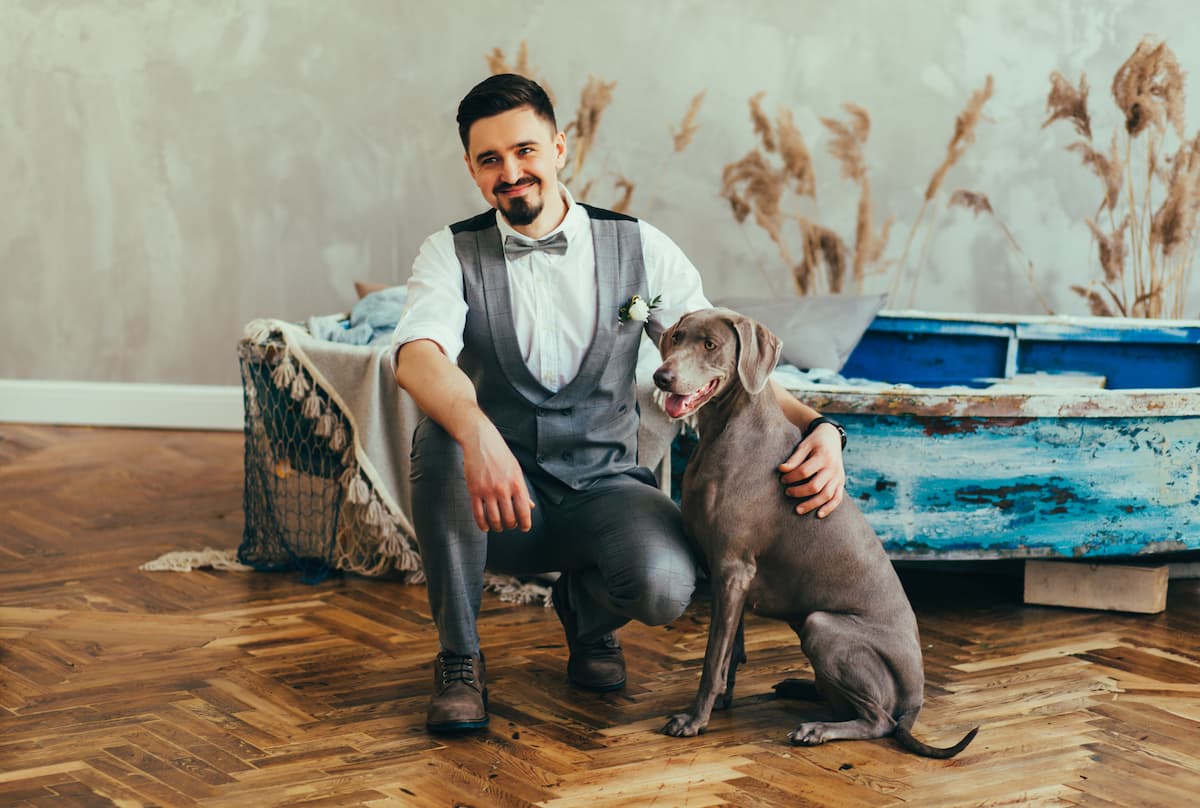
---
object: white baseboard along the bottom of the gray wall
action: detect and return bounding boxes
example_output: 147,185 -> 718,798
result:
0,379 -> 242,430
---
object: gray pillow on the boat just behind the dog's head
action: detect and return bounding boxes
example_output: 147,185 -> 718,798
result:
716,294 -> 888,370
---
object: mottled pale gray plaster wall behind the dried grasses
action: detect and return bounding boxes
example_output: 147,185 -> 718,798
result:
0,0 -> 1200,384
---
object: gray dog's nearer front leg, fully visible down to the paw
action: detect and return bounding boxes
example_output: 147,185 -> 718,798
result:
662,561 -> 755,737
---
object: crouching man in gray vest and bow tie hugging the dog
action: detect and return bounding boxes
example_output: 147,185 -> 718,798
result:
394,74 -> 845,732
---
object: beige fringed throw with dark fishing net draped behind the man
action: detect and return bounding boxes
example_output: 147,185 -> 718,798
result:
226,319 -> 677,588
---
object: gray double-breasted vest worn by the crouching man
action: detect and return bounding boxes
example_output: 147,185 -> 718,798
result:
450,205 -> 649,490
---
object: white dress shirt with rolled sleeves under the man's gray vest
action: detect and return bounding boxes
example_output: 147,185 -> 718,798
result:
391,185 -> 712,393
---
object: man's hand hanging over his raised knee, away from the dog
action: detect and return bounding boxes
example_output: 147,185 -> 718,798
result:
462,421 -> 533,533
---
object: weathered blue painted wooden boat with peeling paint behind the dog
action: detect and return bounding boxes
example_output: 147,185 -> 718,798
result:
797,312 -> 1200,559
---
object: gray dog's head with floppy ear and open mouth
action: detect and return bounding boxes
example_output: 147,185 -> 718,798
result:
654,309 -> 782,418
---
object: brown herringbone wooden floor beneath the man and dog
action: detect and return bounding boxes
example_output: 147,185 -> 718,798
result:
0,425 -> 1200,808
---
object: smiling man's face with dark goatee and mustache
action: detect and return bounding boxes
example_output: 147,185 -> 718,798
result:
466,107 -> 566,227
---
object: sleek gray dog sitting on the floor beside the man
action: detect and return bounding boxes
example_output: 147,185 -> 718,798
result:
654,309 -> 978,758
